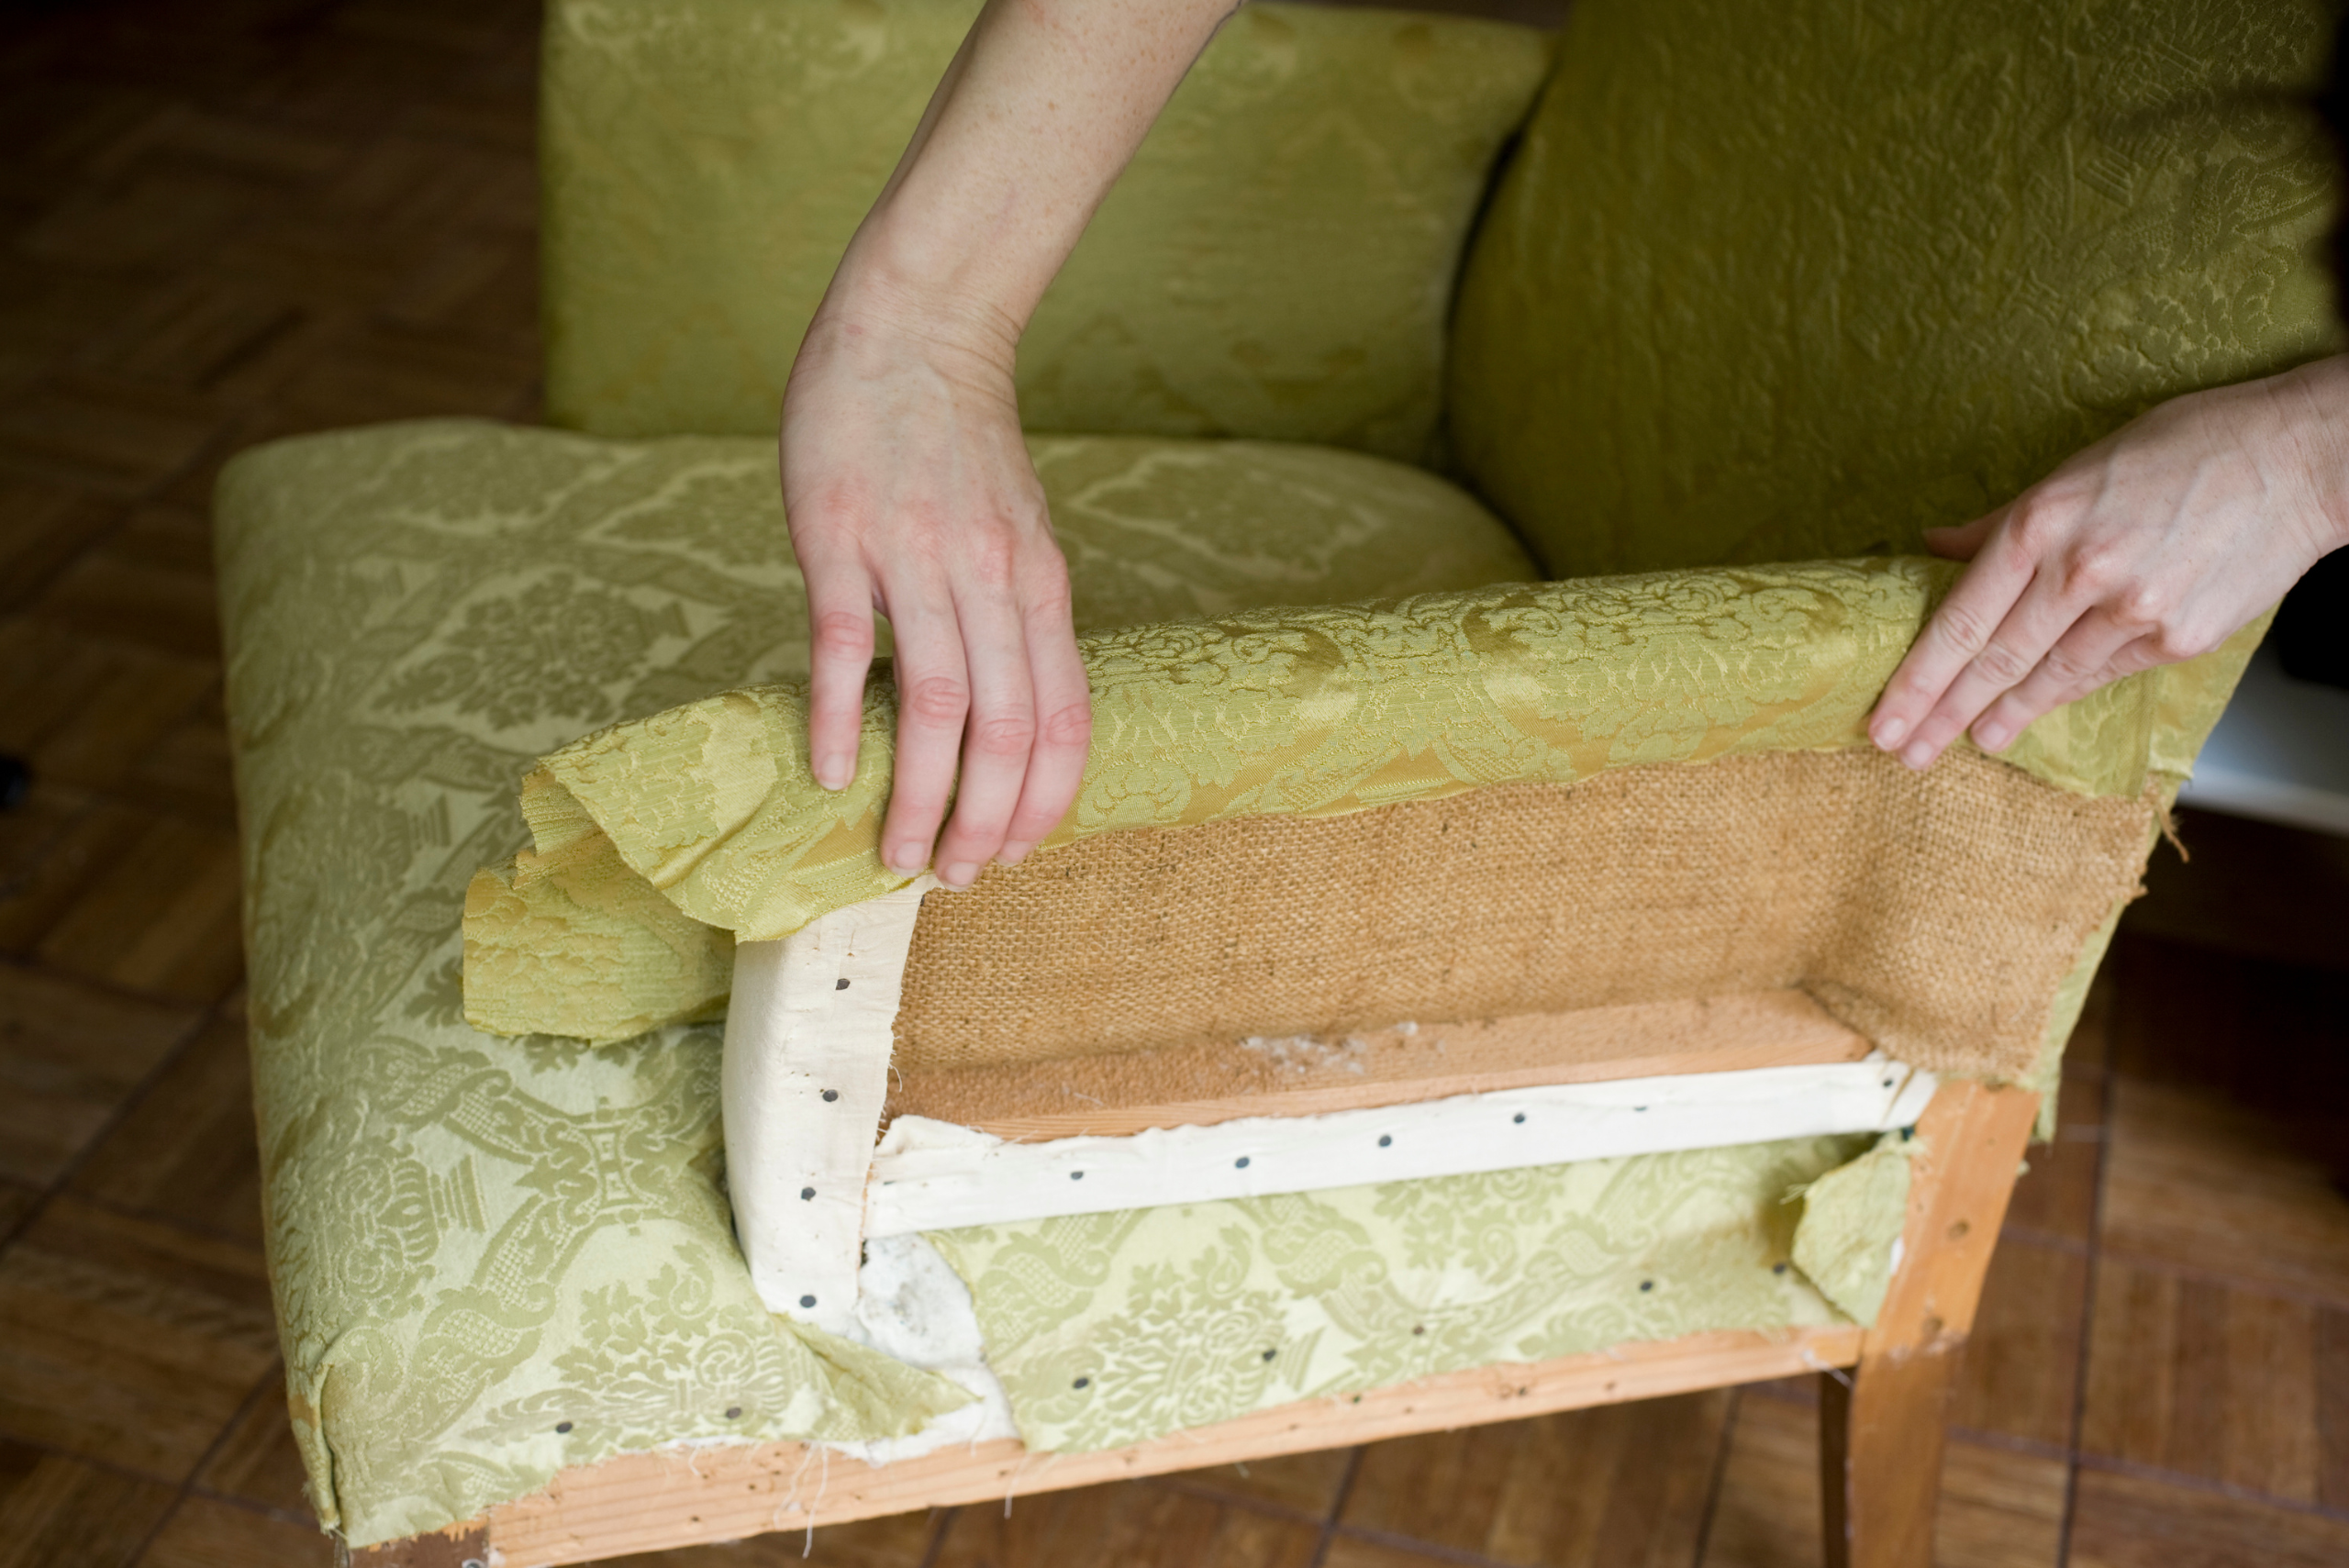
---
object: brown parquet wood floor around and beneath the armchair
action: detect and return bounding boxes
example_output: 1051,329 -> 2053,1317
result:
0,0 -> 2349,1568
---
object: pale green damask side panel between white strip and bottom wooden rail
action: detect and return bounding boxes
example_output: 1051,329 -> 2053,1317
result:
930,1136 -> 1905,1451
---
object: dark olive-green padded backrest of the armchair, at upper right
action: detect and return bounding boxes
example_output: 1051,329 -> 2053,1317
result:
1450,0 -> 2342,577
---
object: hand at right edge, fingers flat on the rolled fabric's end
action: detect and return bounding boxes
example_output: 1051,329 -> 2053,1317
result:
1867,357 -> 2349,768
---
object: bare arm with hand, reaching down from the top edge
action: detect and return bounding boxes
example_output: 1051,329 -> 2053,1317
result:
780,0 -> 1233,885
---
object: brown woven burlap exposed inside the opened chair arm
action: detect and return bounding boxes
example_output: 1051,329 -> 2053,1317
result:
897,749 -> 2154,1080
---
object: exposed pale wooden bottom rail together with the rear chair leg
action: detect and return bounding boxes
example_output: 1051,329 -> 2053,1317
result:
343,1082 -> 2039,1568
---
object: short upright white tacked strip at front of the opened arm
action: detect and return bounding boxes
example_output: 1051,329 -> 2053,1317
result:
721,875 -> 937,1333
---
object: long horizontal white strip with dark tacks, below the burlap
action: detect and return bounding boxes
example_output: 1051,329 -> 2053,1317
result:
864,1054 -> 1933,1237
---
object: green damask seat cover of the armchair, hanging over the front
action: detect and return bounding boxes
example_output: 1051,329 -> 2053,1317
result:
217,420 -> 1530,1544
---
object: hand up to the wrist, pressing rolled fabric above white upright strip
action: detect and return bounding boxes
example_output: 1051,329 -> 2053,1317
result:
782,287 -> 1092,887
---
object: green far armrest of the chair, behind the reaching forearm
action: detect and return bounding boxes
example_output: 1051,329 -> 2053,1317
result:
540,0 -> 1548,460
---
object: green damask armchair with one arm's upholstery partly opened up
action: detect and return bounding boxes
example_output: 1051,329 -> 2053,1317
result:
218,0 -> 2335,1563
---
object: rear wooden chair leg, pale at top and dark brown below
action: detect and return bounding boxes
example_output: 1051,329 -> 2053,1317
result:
1818,1082 -> 2039,1568
